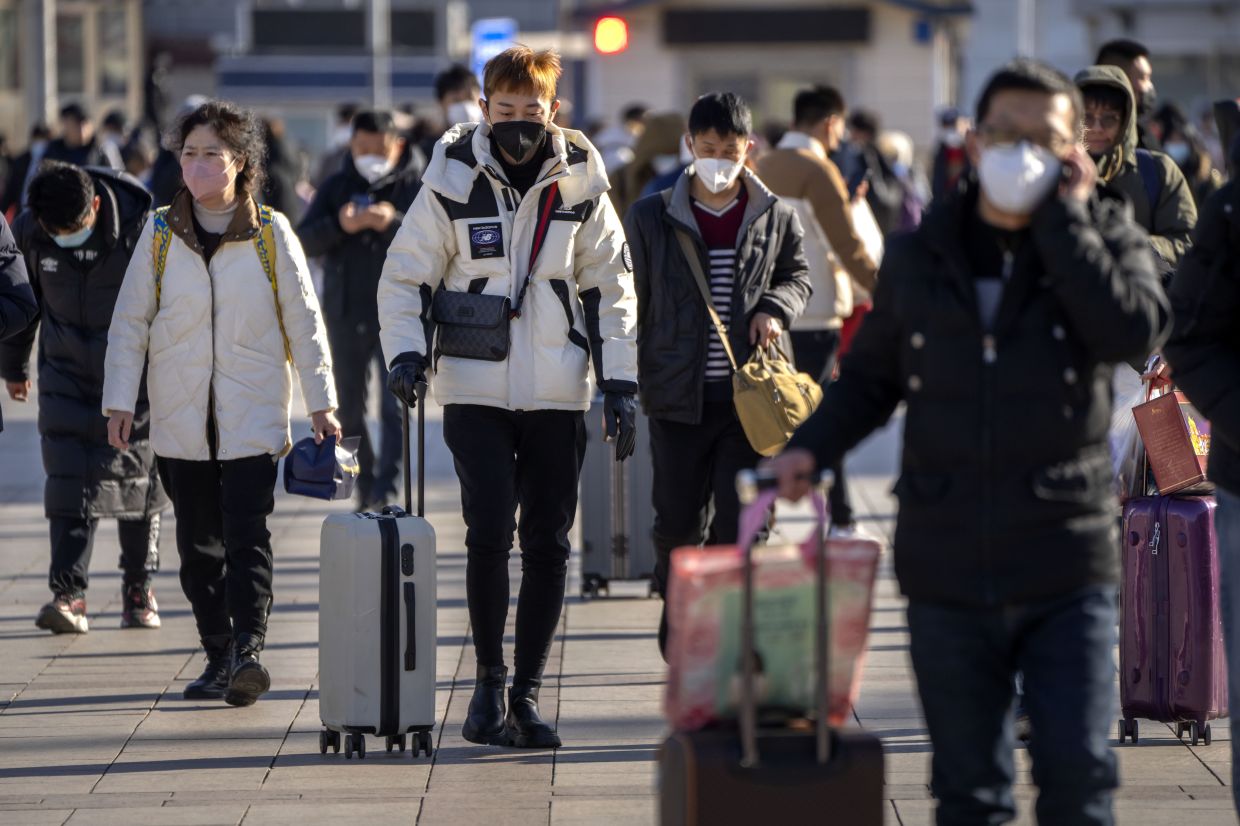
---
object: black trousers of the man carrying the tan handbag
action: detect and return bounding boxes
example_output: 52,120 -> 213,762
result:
650,401 -> 761,593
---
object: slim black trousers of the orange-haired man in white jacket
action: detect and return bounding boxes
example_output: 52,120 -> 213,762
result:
444,404 -> 585,681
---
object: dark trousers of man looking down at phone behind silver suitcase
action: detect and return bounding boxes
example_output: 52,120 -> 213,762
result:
327,320 -> 402,507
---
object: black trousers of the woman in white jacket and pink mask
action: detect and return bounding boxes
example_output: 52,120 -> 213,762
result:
159,454 -> 277,637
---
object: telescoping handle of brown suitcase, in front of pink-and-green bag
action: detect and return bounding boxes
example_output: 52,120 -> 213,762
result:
737,470 -> 835,769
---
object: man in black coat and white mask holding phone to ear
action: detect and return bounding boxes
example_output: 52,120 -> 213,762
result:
773,61 -> 1168,826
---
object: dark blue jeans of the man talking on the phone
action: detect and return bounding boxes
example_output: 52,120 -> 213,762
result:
909,587 -> 1118,826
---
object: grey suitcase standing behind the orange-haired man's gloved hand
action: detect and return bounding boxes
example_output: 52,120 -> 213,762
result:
580,399 -> 655,598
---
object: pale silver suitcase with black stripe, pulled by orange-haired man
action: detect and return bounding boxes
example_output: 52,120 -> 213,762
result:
319,396 -> 435,758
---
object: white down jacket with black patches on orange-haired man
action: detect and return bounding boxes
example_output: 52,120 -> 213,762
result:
378,124 -> 637,411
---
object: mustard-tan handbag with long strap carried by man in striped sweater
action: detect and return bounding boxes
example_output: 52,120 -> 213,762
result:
676,229 -> 822,456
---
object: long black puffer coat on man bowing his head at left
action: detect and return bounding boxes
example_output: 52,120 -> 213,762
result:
0,167 -> 167,520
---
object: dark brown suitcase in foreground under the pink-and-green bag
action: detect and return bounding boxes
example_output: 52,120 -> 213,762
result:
658,473 -> 883,826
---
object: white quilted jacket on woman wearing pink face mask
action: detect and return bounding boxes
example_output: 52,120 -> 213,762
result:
103,190 -> 336,460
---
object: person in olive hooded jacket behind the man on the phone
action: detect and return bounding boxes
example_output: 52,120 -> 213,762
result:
1075,66 -> 1197,282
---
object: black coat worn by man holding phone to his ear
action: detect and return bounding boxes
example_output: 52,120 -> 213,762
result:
790,185 -> 1171,606
